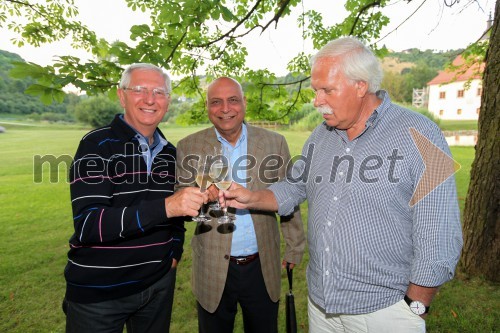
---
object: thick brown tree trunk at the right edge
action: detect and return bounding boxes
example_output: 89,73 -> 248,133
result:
460,1 -> 500,282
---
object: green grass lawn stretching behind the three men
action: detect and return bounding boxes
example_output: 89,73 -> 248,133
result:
0,120 -> 500,333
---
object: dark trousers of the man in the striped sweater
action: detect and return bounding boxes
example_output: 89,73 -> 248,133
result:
63,268 -> 176,333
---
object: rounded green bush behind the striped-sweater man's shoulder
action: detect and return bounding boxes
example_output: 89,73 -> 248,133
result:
75,95 -> 123,128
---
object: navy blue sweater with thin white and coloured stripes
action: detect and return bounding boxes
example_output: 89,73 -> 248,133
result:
65,115 -> 185,303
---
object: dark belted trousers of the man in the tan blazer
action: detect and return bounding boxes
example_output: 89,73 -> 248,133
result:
198,259 -> 279,333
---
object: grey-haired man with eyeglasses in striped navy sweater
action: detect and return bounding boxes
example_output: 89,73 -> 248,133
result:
63,64 -> 208,333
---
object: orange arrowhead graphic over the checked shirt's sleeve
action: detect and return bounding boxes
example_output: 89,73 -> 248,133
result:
409,127 -> 461,207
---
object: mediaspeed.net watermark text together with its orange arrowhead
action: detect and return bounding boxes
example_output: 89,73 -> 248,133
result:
33,128 -> 460,206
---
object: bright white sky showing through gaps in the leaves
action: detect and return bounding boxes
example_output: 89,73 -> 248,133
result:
0,0 -> 495,75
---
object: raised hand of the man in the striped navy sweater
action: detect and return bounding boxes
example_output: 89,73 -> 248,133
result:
165,187 -> 208,217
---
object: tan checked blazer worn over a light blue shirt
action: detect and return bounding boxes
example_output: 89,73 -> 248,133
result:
176,125 -> 305,313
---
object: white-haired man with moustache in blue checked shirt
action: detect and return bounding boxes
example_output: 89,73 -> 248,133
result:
225,37 -> 462,332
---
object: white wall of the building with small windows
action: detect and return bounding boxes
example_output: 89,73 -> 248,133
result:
428,79 -> 482,120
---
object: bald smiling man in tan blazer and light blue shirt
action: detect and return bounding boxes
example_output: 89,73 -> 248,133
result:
177,77 -> 305,333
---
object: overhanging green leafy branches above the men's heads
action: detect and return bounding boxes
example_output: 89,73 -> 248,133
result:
0,0 -> 389,121
